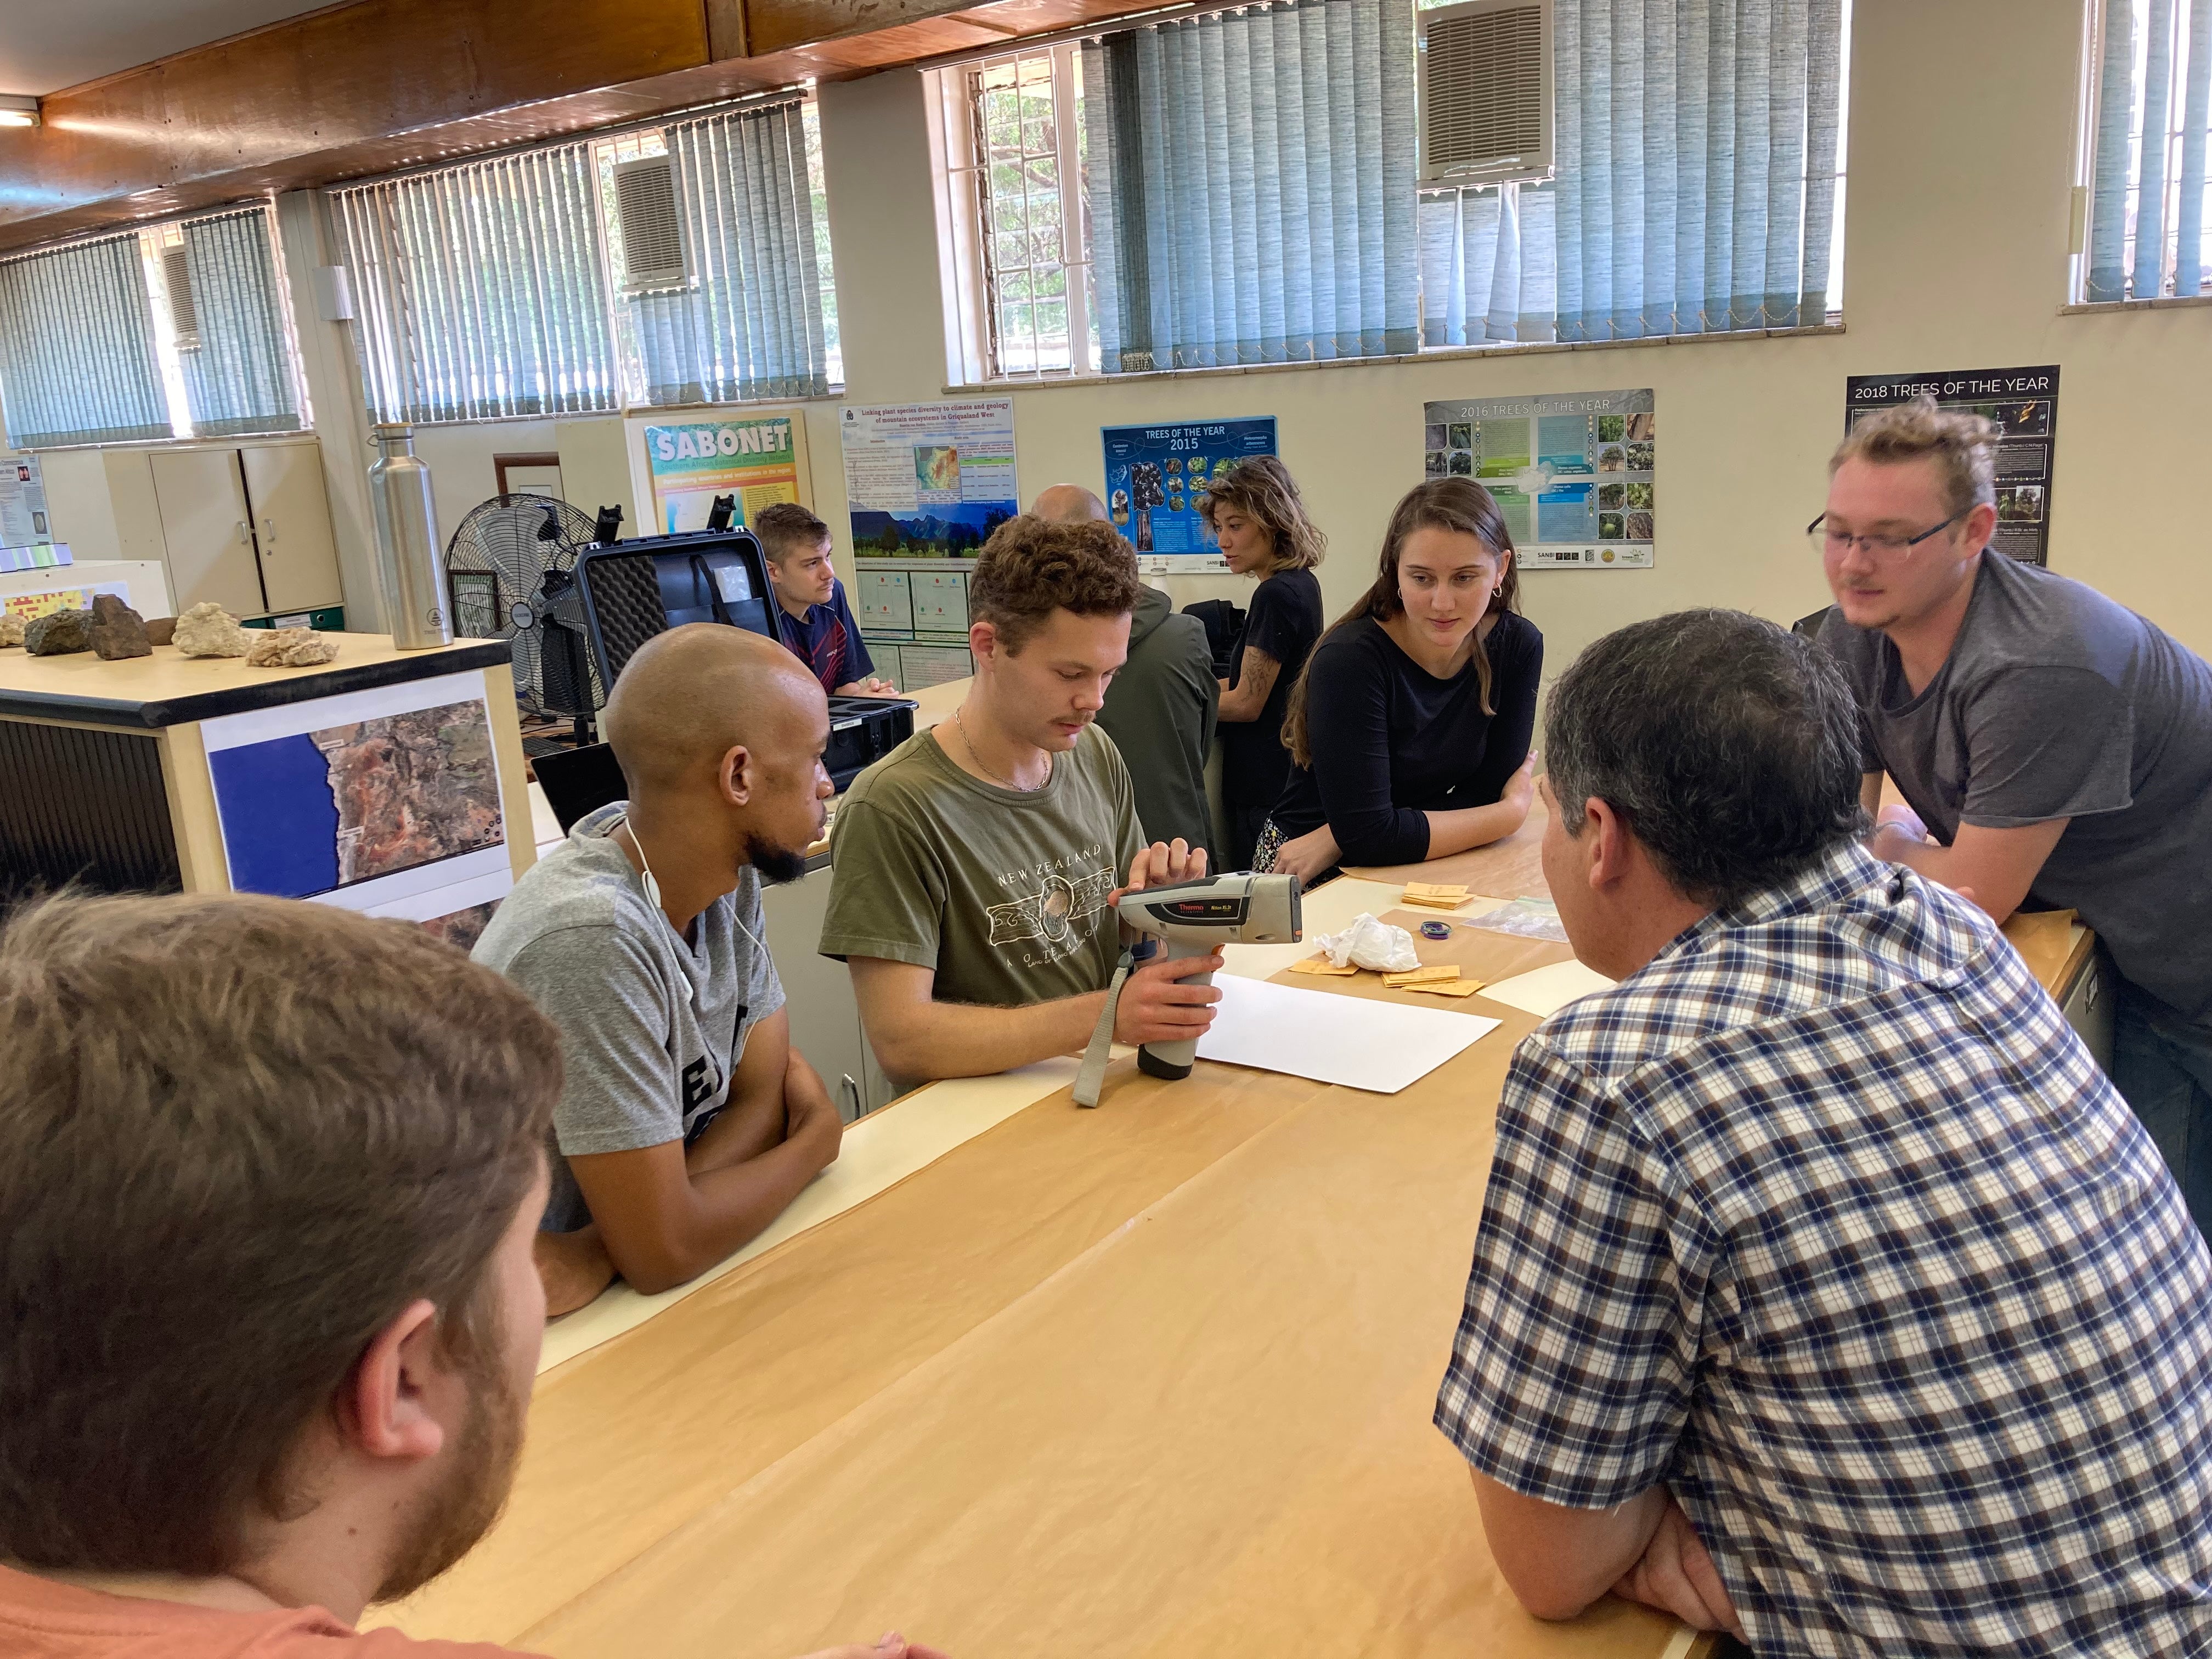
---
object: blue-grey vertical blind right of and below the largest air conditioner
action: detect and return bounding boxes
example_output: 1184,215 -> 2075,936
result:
1423,0 -> 1843,345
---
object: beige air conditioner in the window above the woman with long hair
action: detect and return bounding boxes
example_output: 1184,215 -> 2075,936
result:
1415,0 -> 1550,184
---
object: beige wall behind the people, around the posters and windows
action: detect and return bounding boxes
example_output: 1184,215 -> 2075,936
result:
55,0 -> 2212,673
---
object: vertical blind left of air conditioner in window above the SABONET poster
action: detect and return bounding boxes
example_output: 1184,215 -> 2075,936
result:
332,144 -> 622,422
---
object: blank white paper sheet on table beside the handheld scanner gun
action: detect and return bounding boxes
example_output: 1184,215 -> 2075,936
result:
1199,973 -> 1502,1095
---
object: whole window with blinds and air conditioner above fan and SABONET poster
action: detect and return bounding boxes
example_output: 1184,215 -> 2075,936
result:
334,97 -> 843,422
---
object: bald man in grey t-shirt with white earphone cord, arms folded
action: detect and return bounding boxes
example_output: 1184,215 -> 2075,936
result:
473,622 -> 840,1314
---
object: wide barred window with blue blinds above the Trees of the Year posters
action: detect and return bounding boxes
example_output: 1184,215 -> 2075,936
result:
934,0 -> 1849,381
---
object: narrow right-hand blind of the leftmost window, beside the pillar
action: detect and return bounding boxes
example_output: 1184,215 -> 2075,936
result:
177,208 -> 301,438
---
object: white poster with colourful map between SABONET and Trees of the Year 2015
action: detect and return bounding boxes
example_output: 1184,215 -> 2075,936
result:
838,398 -> 1022,560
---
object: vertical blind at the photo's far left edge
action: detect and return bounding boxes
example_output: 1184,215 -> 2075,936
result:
0,230 -> 175,449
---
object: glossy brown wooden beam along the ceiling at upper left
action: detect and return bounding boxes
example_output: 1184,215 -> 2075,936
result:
0,0 -> 1159,252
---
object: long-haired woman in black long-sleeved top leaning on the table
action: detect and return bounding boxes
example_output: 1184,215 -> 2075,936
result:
1254,478 -> 1544,885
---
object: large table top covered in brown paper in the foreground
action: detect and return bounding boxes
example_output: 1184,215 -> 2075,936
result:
392,883 -> 1701,1659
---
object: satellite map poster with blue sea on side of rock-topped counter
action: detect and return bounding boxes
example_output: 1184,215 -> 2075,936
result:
199,673 -> 513,947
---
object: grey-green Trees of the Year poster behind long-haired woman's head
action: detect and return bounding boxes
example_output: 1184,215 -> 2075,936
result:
1423,387 -> 1659,571
